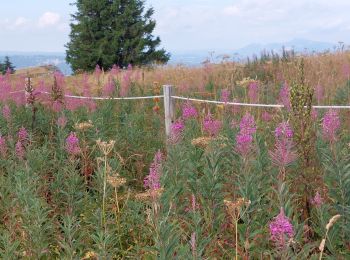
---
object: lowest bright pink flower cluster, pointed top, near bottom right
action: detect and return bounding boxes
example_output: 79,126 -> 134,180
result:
269,208 -> 294,249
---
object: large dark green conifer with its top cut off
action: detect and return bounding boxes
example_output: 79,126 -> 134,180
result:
66,0 -> 170,72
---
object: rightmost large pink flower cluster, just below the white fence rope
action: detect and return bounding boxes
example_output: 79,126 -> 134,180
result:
322,109 -> 340,142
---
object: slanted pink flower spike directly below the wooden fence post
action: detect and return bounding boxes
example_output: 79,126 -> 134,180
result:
143,151 -> 162,192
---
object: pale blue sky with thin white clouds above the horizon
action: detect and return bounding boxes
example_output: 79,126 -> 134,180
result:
0,0 -> 350,52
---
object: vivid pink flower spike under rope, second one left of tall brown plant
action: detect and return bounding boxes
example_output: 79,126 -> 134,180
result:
236,114 -> 256,157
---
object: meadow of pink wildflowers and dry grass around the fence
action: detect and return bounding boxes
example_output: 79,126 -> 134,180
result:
0,53 -> 350,259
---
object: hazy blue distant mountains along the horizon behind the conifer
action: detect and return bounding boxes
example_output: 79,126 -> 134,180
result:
0,39 -> 339,75
